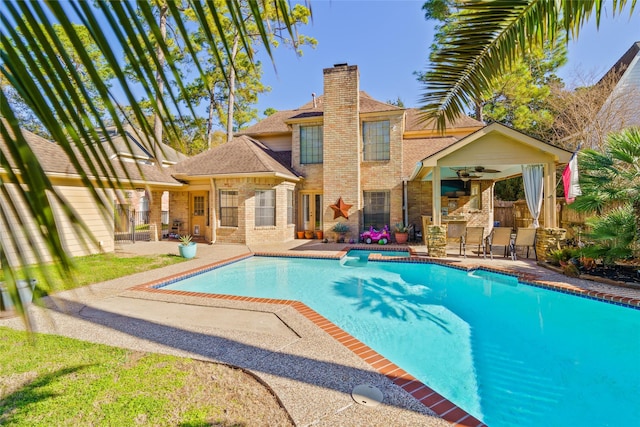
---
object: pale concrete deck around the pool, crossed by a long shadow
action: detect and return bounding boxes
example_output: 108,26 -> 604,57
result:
0,240 -> 640,426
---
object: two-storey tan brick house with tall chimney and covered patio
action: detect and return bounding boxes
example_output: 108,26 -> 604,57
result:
169,64 -> 571,245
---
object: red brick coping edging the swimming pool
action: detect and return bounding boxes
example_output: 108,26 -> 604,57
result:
130,246 -> 640,427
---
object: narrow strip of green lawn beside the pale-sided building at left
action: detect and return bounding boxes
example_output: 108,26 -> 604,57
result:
0,254 -> 186,294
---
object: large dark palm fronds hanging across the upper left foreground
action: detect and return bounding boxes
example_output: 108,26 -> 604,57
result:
0,0 -> 294,325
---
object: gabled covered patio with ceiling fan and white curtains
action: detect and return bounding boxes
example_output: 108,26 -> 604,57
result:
405,123 -> 572,256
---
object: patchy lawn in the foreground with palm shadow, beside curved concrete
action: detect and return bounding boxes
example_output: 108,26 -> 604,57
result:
0,327 -> 291,426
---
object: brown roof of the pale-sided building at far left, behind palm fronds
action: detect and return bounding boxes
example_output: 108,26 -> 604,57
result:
0,122 -> 180,185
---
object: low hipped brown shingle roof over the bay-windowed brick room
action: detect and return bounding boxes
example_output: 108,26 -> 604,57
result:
171,135 -> 300,180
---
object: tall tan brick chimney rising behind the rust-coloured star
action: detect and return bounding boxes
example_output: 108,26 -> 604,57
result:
322,64 -> 362,233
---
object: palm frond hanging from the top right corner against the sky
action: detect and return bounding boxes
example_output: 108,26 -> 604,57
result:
421,0 -> 635,130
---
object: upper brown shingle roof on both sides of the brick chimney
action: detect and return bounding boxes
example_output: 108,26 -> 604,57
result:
236,91 -> 404,135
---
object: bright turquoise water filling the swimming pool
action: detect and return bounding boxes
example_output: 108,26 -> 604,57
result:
164,256 -> 640,427
